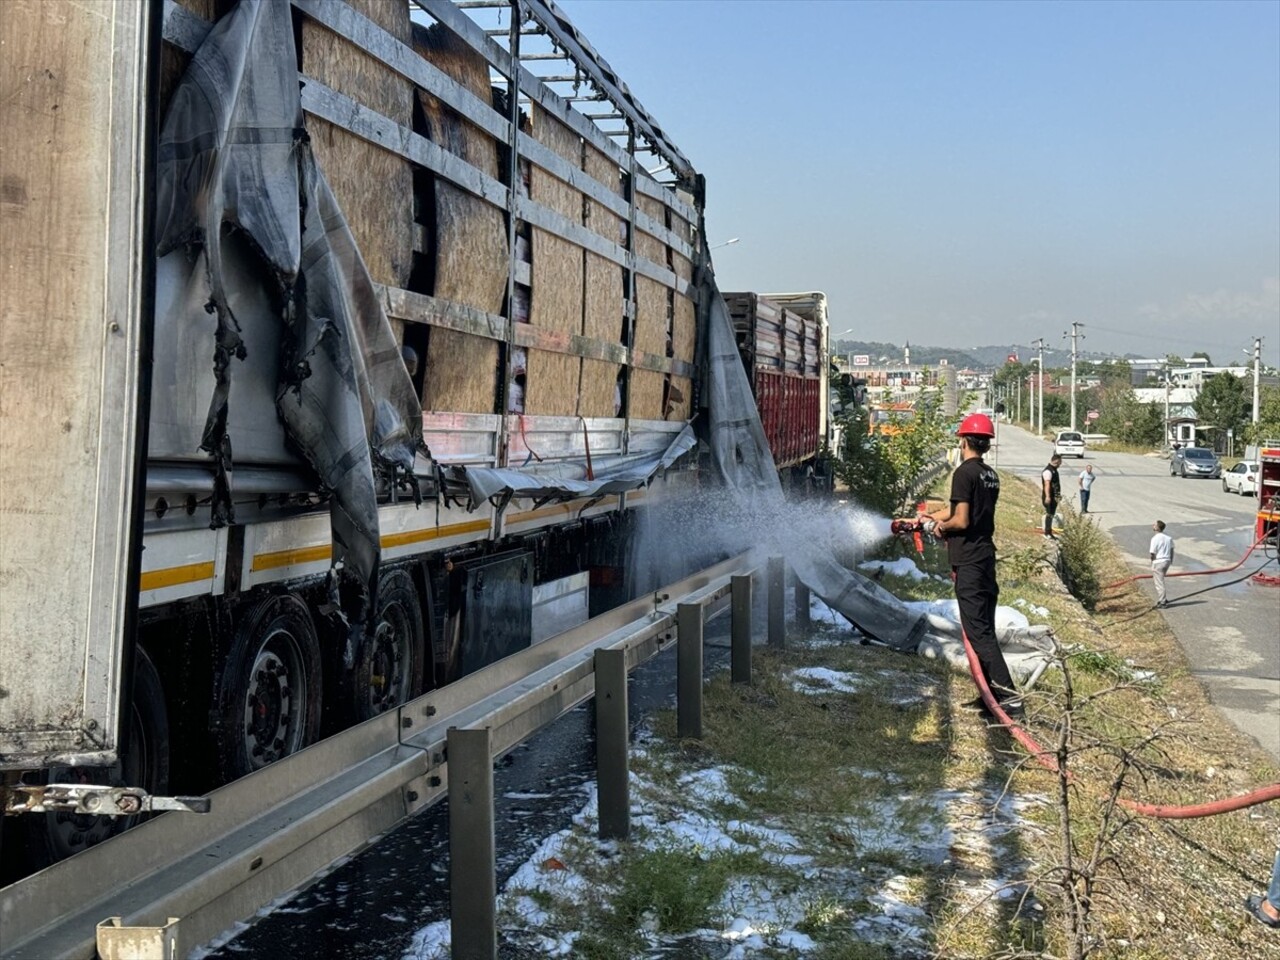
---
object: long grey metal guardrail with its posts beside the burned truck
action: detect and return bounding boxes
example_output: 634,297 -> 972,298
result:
0,554 -> 783,960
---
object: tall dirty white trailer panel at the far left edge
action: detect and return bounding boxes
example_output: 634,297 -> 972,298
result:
0,0 -> 148,769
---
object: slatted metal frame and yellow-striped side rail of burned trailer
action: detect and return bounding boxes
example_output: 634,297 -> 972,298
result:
140,0 -> 708,608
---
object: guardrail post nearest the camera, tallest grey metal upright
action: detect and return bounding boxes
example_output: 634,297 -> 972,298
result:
448,727 -> 498,960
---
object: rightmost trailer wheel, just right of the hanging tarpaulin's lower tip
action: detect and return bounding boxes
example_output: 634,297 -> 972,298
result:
349,570 -> 425,723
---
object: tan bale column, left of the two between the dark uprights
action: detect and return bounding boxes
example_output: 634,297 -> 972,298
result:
525,105 -> 585,416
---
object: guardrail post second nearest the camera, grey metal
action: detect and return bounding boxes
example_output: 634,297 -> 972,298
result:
595,650 -> 631,840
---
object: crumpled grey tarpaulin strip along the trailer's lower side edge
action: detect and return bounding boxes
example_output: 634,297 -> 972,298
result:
447,426 -> 698,509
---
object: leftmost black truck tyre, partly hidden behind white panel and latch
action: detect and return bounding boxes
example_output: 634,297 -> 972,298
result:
26,646 -> 169,869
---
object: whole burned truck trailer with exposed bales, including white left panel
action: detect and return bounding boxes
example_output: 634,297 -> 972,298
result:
0,0 -> 707,858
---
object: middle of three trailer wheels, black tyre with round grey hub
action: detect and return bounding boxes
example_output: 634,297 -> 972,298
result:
218,595 -> 320,781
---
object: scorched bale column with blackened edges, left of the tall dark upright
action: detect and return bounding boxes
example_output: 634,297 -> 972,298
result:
413,24 -> 508,413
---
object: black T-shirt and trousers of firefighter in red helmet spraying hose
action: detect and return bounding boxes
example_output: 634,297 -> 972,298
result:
947,457 -> 1016,700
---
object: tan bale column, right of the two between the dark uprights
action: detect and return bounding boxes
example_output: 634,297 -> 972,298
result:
579,145 -> 626,417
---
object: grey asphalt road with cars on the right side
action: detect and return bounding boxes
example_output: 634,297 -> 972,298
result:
988,424 -> 1280,760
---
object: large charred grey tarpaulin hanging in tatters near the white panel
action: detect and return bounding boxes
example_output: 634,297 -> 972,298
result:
156,0 -> 421,662
